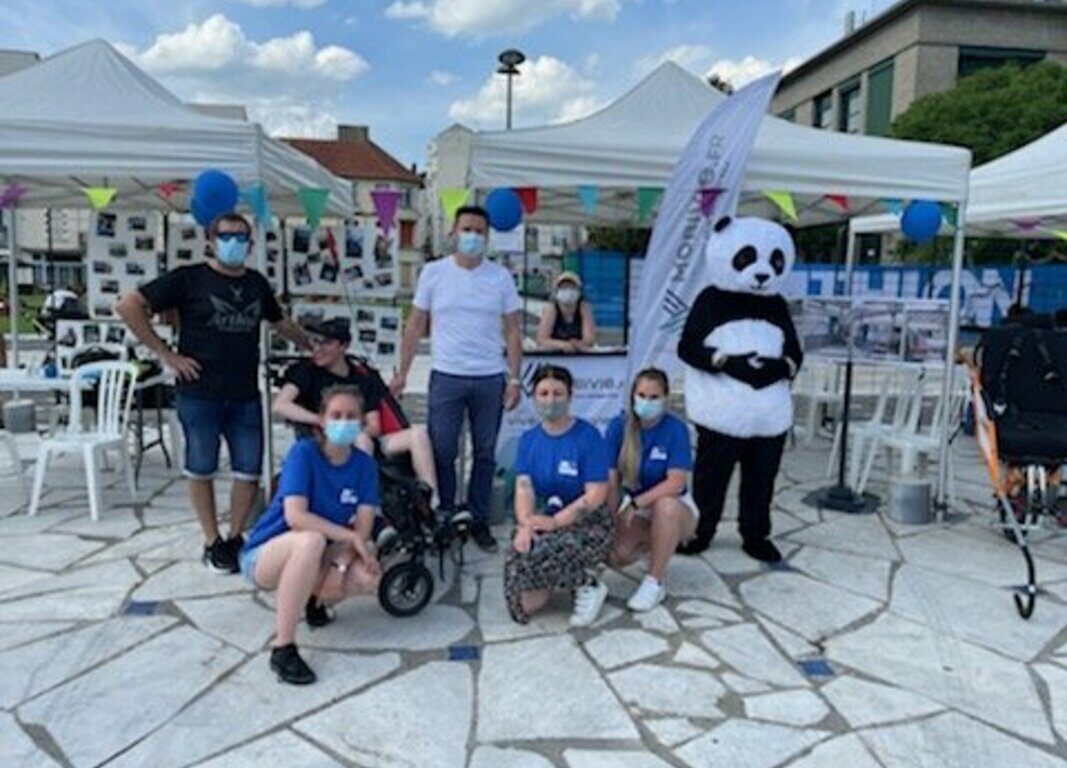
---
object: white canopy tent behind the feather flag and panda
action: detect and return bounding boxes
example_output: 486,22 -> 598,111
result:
454,63 -> 971,509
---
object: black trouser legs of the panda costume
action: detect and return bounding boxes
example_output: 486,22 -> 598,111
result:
692,426 -> 785,546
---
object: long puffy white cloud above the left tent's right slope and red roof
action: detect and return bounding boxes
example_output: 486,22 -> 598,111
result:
122,14 -> 368,80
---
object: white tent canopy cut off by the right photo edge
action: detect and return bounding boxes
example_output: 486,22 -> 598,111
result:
851,124 -> 1067,239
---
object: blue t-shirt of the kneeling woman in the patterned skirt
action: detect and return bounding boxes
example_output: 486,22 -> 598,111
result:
514,419 -> 607,513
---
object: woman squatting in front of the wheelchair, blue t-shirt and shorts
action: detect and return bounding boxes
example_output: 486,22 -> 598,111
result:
239,385 -> 380,685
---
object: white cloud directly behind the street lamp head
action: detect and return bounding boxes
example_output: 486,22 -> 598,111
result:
448,55 -> 600,128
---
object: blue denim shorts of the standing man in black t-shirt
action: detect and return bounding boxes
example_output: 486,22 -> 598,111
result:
177,394 -> 264,480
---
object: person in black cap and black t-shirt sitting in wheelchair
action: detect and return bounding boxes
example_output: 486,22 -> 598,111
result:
273,318 -> 446,508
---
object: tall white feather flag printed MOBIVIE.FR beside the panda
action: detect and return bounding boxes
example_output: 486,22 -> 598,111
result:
627,73 -> 781,380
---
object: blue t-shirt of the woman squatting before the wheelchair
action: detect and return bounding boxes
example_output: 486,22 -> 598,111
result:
244,439 -> 378,549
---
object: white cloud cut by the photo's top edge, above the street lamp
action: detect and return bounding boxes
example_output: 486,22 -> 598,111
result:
385,0 -> 628,37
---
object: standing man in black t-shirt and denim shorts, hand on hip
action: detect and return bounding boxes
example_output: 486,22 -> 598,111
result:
115,213 -> 308,573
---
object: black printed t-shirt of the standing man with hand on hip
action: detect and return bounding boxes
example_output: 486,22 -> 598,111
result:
140,263 -> 282,400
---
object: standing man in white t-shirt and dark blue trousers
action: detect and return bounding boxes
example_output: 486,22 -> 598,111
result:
389,206 -> 522,551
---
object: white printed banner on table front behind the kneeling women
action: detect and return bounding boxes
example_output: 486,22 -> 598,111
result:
496,354 -> 627,467
